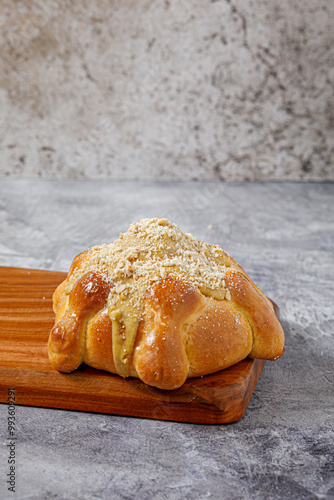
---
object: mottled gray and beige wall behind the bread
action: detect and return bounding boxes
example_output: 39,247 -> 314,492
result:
0,0 -> 334,180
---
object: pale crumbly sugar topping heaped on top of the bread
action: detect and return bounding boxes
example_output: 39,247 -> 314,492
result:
69,218 -> 230,305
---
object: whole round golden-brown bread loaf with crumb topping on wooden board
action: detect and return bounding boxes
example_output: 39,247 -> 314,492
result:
48,219 -> 284,389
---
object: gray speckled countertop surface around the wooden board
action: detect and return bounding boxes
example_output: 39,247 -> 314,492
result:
0,179 -> 334,500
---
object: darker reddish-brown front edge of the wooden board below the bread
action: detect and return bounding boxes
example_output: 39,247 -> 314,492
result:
0,358 -> 265,424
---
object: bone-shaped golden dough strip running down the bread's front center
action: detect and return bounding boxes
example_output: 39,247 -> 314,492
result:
133,278 -> 205,389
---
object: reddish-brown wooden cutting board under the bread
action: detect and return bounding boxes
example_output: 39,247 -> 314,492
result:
0,267 -> 279,424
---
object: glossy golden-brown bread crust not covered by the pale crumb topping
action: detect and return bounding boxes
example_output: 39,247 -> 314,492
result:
48,220 -> 284,389
